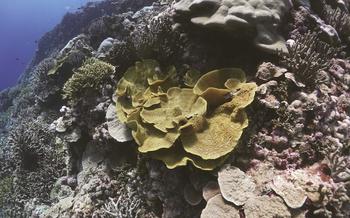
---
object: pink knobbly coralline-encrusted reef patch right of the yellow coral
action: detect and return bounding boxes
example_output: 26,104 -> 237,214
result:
255,60 -> 350,168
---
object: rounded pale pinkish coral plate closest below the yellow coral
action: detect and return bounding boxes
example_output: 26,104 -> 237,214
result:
218,165 -> 255,206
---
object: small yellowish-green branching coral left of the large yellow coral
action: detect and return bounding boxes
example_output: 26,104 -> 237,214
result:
63,58 -> 115,104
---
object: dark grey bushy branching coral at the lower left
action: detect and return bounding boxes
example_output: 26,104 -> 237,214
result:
9,120 -> 65,210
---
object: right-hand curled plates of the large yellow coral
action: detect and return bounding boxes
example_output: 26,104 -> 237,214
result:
180,68 -> 257,160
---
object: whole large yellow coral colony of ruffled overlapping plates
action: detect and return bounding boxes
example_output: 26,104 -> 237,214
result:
117,60 -> 257,170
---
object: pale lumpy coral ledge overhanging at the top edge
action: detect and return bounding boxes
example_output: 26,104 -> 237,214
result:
174,0 -> 292,53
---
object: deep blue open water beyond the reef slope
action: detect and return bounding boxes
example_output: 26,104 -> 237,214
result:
0,0 -> 100,91
